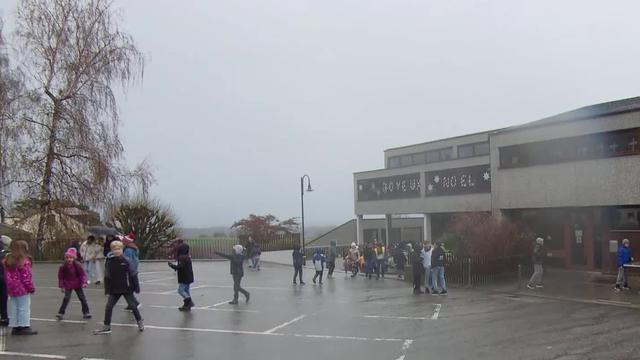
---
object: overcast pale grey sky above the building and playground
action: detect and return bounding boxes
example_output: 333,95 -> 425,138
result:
0,0 -> 640,227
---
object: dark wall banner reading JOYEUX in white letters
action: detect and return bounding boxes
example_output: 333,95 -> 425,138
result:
358,173 -> 420,201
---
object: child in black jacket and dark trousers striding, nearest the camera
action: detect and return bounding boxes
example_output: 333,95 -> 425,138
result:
93,241 -> 144,335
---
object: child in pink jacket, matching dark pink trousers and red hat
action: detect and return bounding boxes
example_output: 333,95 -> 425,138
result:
56,248 -> 91,320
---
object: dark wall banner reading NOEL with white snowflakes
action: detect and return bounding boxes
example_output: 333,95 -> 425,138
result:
425,165 -> 491,196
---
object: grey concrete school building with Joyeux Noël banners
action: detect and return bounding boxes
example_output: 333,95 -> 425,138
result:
348,97 -> 640,270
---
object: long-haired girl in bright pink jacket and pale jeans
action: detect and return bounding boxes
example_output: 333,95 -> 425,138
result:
3,240 -> 38,335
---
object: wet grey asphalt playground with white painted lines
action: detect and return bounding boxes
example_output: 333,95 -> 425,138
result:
0,262 -> 640,360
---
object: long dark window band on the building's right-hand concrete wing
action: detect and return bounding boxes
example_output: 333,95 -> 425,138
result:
500,128 -> 640,168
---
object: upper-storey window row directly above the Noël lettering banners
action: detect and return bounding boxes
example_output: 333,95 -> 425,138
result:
389,141 -> 489,169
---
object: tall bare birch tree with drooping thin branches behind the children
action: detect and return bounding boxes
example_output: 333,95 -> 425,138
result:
15,0 -> 145,253
